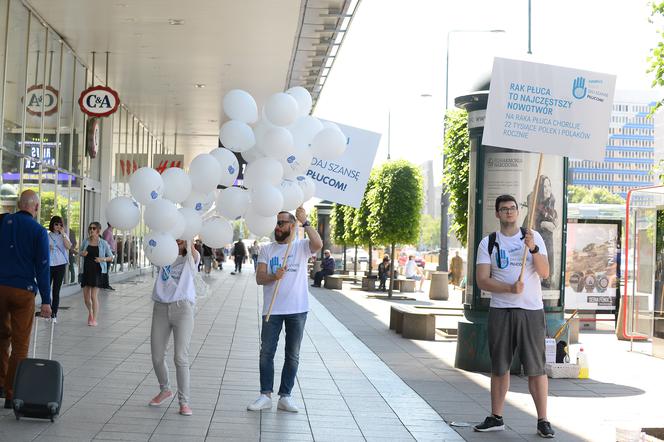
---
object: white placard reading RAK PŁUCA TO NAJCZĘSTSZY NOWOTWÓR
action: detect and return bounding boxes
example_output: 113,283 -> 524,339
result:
482,58 -> 616,161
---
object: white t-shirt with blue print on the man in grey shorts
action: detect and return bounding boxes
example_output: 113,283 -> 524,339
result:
476,230 -> 546,310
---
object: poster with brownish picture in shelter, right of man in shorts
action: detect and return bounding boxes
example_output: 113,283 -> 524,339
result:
565,220 -> 621,311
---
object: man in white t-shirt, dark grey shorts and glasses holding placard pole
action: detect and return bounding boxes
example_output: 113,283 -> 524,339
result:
474,195 -> 554,438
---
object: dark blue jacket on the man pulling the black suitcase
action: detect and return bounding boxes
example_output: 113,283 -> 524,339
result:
0,211 -> 51,304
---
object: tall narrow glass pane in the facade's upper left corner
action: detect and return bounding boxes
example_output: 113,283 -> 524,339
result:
3,1 -> 29,152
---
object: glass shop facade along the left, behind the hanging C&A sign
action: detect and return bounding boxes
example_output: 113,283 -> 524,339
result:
0,0 -> 175,284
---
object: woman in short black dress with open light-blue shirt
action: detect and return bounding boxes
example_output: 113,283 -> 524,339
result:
79,221 -> 113,327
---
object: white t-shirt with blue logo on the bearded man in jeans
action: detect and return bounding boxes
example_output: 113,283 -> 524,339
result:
258,239 -> 312,315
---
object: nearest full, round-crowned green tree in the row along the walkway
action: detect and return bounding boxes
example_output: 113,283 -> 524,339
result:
368,160 -> 424,296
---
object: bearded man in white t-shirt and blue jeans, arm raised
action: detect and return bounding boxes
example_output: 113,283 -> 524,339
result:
247,207 -> 323,413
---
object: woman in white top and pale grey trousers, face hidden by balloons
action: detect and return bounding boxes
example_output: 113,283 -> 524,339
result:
150,239 -> 200,416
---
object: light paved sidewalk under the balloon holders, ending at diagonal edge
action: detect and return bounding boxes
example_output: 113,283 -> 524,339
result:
0,271 -> 462,441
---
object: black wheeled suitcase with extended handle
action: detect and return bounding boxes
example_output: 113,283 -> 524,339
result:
12,317 -> 64,422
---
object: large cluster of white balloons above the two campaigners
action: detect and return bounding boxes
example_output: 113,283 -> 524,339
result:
106,86 -> 346,266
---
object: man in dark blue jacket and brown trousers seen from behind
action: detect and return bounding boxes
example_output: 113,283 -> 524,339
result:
0,190 -> 52,409
